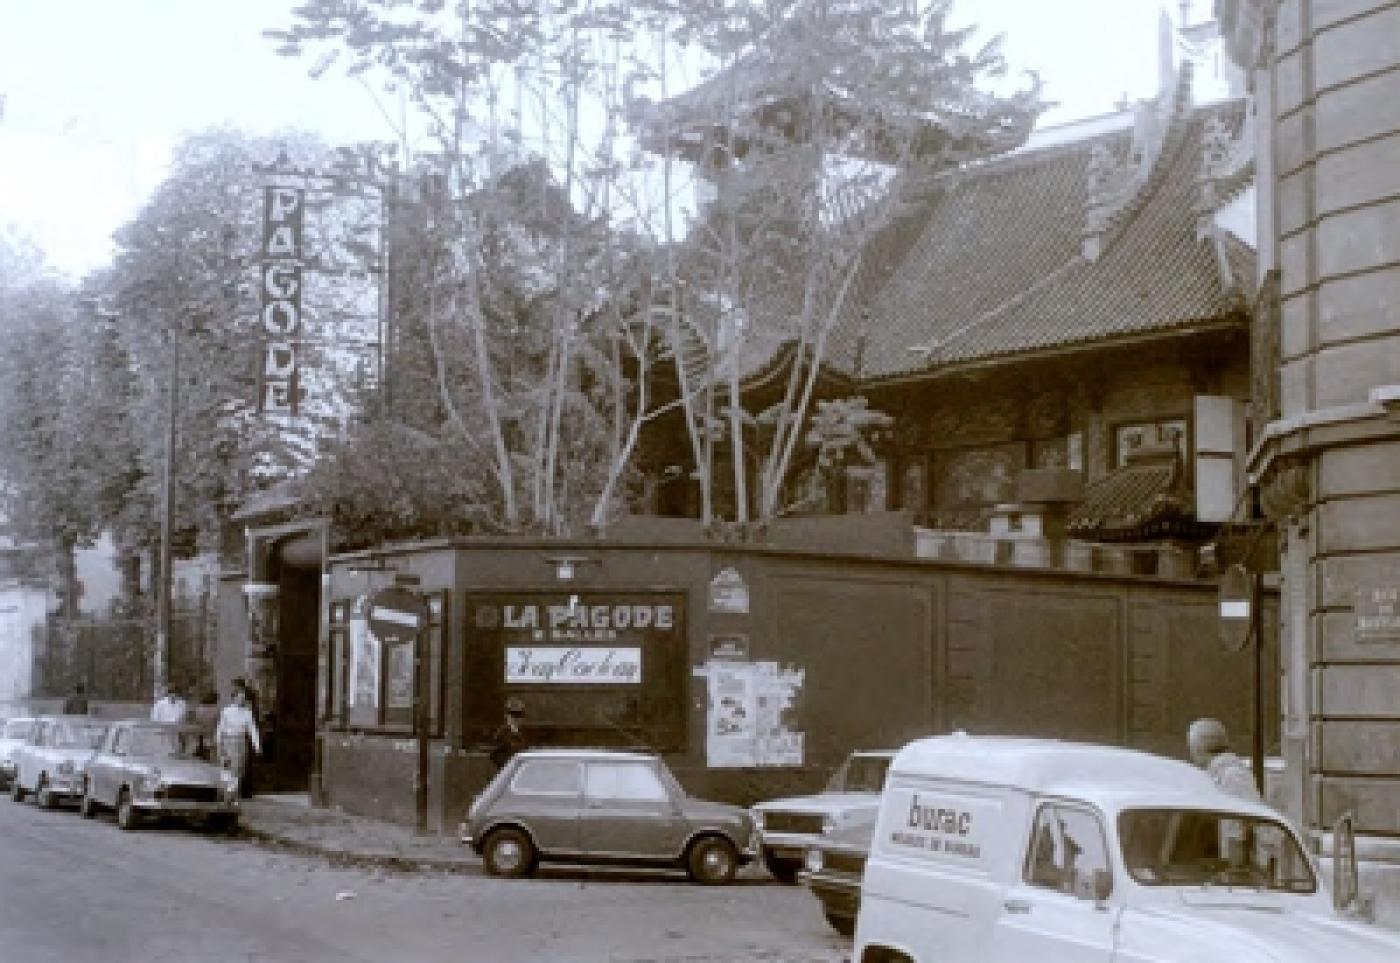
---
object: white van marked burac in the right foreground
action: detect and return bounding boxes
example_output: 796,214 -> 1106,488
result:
853,733 -> 1400,963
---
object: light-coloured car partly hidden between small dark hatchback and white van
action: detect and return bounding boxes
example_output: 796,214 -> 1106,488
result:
753,750 -> 895,883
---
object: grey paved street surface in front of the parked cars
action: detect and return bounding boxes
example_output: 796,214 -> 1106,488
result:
0,798 -> 848,963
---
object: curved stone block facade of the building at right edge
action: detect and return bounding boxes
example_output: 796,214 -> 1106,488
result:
1224,0 -> 1400,920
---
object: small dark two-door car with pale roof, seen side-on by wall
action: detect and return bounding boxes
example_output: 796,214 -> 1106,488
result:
462,749 -> 755,883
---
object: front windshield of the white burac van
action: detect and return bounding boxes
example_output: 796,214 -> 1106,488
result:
1119,809 -> 1317,893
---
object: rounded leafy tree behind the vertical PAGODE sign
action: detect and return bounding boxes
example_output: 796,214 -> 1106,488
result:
101,130 -> 374,550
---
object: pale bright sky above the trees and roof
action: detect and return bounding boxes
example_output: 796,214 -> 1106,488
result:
0,0 -> 1210,276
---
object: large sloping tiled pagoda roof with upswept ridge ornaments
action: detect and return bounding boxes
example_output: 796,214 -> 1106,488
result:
829,103 -> 1249,379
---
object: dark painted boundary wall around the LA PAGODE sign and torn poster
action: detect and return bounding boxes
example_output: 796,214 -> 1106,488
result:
321,540 -> 1278,830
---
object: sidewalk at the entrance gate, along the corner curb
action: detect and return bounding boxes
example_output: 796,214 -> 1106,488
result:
239,792 -> 482,872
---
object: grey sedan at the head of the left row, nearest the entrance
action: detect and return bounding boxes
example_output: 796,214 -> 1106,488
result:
81,719 -> 238,830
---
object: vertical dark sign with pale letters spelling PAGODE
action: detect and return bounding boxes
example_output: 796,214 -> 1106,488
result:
258,188 -> 307,414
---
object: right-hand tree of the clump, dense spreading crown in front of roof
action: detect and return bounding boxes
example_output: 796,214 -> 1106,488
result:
633,0 -> 1042,522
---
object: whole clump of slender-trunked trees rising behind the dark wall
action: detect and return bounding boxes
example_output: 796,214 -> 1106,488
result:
269,0 -> 1039,532
